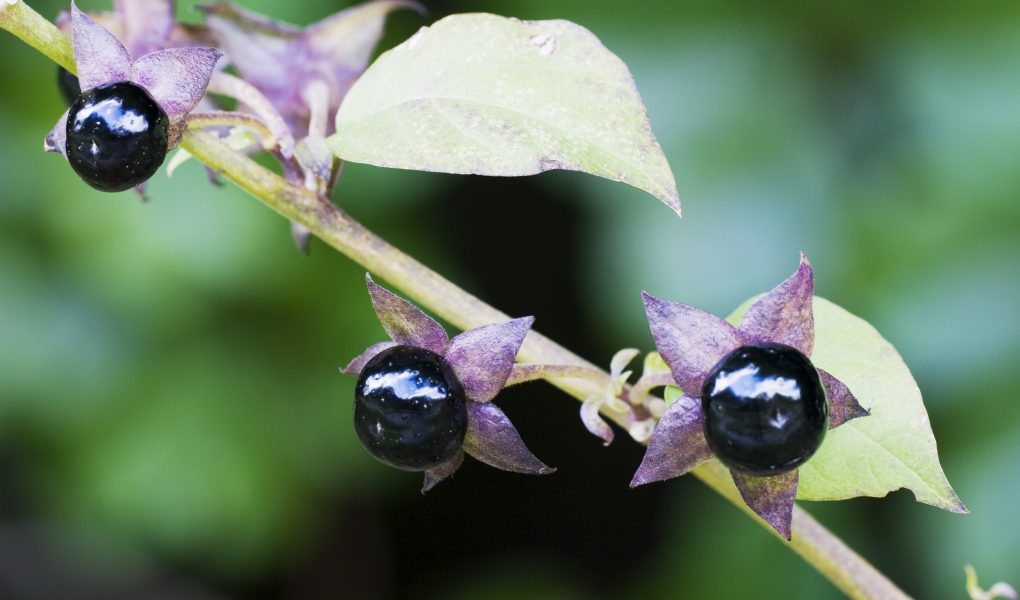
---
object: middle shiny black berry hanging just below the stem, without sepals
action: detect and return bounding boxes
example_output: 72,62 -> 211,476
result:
354,346 -> 467,470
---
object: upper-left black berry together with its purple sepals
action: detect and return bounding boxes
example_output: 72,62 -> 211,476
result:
44,4 -> 221,192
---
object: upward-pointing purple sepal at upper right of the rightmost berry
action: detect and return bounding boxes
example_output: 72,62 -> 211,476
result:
737,253 -> 815,356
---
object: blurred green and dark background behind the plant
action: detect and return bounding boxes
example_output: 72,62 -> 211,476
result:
0,0 -> 1020,599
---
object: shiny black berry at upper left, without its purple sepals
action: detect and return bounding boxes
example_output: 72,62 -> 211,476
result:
66,82 -> 169,192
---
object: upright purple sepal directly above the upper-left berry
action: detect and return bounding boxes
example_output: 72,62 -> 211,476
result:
70,3 -> 131,92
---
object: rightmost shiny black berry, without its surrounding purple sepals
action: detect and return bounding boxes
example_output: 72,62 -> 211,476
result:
702,344 -> 828,476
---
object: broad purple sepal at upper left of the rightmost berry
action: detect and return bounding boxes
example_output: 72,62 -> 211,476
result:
642,292 -> 741,396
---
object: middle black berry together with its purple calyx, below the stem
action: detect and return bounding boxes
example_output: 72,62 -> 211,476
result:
341,277 -> 556,492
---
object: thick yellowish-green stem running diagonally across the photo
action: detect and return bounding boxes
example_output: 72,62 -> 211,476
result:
0,5 -> 907,599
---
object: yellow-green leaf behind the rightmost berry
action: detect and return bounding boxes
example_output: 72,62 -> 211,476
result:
729,296 -> 967,512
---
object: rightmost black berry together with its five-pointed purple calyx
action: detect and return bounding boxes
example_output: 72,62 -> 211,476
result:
630,255 -> 868,540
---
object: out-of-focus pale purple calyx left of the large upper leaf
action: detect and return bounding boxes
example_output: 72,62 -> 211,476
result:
199,0 -> 423,138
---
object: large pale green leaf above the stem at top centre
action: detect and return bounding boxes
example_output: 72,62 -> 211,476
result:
328,13 -> 680,214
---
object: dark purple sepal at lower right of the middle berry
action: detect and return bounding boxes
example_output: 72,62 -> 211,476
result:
464,402 -> 556,474
